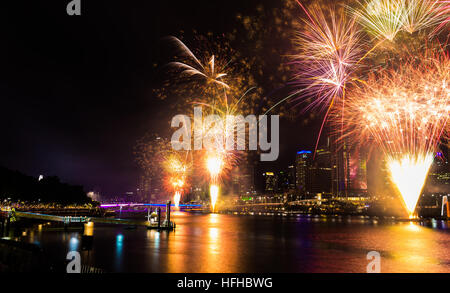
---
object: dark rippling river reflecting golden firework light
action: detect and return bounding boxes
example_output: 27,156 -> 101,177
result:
14,212 -> 450,273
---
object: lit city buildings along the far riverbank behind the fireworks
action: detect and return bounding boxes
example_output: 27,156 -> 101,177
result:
103,142 -> 450,202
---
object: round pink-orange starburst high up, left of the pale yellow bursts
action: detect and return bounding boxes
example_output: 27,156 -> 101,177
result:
293,4 -> 365,110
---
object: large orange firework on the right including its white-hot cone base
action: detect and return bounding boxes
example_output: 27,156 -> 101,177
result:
340,50 -> 450,214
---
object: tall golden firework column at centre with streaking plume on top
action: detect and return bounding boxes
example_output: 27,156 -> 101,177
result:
160,37 -> 254,212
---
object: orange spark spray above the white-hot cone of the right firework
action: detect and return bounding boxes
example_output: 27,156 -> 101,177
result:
344,55 -> 450,154
